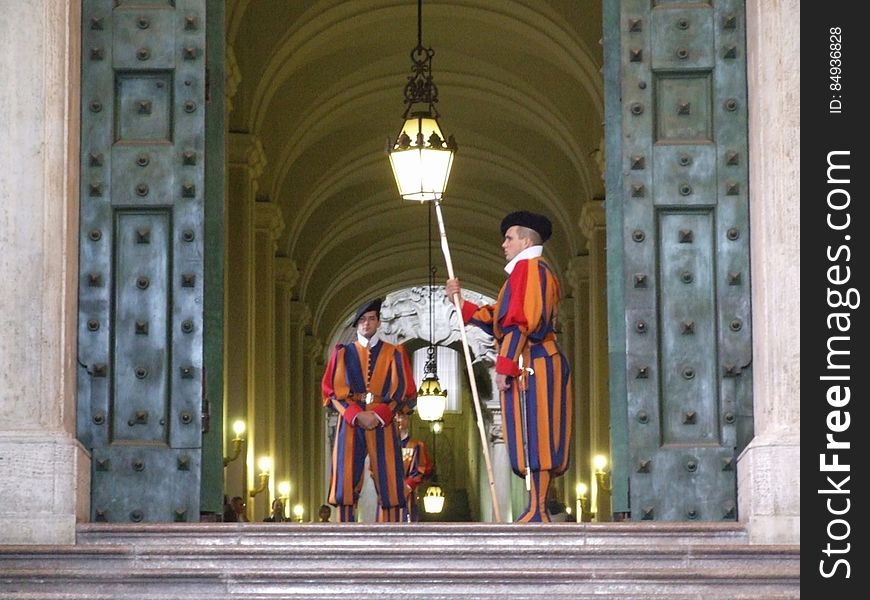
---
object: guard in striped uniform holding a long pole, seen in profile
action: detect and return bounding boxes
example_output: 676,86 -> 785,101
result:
446,211 -> 572,523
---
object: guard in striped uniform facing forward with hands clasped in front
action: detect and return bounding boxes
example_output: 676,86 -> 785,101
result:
321,298 -> 417,522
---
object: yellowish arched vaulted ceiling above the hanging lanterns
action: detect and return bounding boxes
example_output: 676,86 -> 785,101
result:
226,0 -> 604,341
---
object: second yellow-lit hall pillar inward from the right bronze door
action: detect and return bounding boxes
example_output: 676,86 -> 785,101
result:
560,256 -> 592,506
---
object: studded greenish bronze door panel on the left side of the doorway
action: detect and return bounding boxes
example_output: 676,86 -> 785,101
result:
77,0 -> 205,522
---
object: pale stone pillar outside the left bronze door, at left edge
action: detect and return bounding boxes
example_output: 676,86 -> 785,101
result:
0,0 -> 90,544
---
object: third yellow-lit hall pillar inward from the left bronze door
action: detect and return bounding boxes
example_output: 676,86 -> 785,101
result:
273,256 -> 299,515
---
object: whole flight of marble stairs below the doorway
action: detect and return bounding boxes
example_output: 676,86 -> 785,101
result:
0,522 -> 800,600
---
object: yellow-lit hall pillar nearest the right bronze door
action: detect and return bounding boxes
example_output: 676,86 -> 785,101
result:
580,200 -> 611,521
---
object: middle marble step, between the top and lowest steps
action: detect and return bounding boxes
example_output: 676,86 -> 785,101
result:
0,543 -> 800,573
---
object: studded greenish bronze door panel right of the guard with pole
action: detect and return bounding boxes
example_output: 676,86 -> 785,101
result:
608,0 -> 751,521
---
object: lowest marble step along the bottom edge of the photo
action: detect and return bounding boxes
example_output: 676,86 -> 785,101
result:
0,558 -> 800,600
